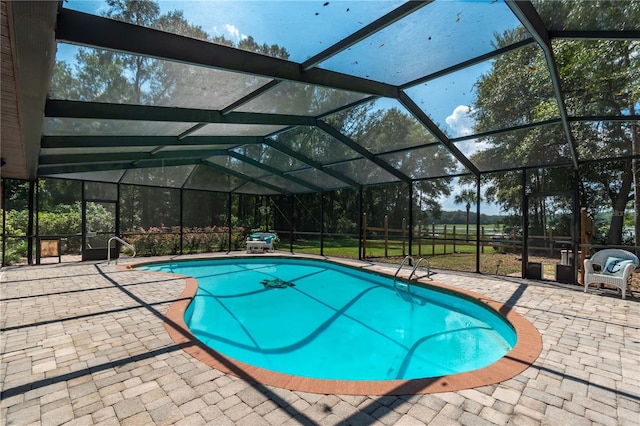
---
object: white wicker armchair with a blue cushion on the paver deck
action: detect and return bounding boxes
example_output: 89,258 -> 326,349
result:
584,249 -> 640,299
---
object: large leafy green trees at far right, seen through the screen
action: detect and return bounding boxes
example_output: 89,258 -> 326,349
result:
472,0 -> 640,244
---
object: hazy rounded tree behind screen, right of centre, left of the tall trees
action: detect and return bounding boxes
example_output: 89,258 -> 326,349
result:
325,103 -> 455,228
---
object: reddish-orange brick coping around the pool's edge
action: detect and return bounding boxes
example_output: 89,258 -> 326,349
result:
128,256 -> 542,395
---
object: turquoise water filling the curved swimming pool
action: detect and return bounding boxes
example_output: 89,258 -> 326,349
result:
144,258 -> 516,380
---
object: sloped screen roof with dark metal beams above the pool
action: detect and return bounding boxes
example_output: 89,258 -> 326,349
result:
25,0 -> 640,194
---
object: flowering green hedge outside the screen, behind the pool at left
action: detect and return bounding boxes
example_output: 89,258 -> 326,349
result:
122,226 -> 246,256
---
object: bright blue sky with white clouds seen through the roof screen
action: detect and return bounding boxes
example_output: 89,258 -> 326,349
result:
58,0 -> 515,214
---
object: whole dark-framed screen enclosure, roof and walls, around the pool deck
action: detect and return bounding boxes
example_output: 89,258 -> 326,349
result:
1,0 -> 640,282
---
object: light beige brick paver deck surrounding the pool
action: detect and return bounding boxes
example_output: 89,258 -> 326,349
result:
0,255 -> 640,426
